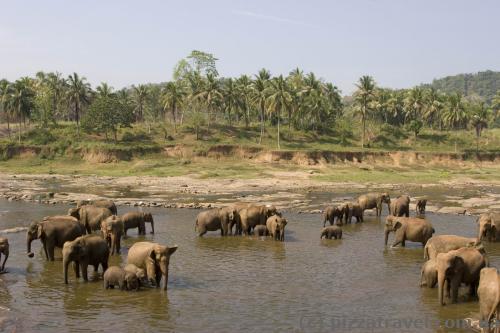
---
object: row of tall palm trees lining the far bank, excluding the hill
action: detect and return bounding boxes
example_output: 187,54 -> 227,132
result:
0,51 -> 500,148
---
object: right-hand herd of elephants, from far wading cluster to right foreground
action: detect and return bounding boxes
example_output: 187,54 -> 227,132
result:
321,193 -> 500,332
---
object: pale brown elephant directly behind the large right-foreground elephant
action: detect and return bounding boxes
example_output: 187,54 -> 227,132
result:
424,235 -> 484,260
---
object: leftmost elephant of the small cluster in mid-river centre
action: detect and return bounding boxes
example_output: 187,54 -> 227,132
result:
194,207 -> 238,237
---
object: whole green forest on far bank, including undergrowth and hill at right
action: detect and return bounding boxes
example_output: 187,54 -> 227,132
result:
0,51 -> 500,149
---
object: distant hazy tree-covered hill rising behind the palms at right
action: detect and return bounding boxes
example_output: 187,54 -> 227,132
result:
424,71 -> 500,103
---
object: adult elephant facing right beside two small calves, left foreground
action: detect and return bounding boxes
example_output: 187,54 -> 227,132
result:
127,242 -> 177,290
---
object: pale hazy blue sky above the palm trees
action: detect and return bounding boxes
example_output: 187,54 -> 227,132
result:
0,0 -> 500,94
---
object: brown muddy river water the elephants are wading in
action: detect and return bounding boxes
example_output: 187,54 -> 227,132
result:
0,201 -> 500,332
